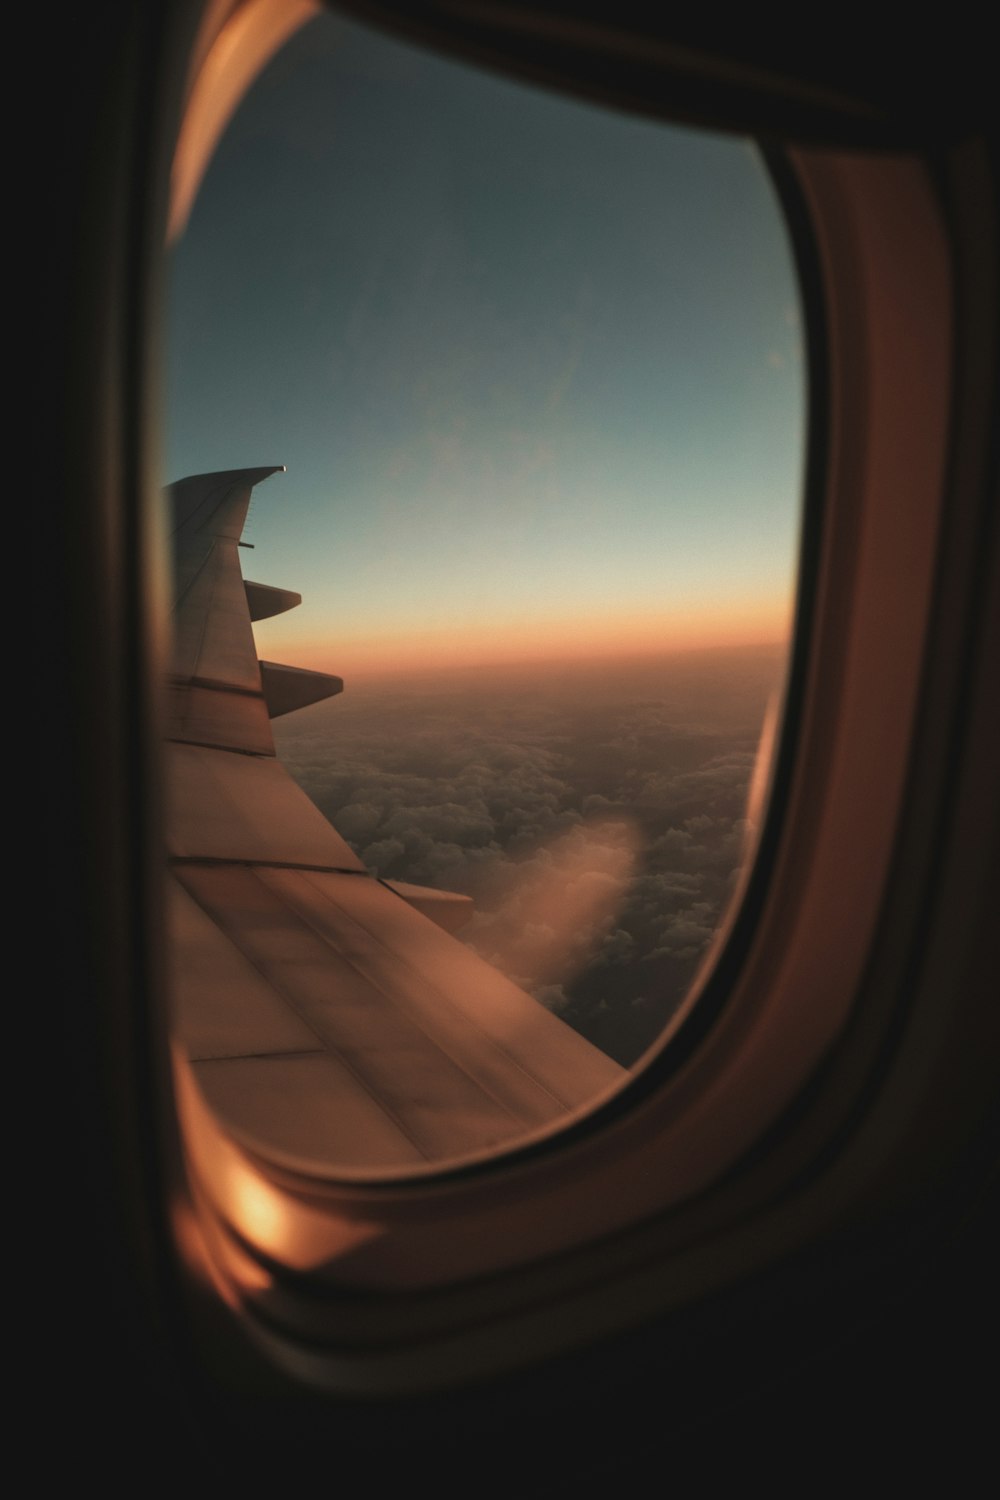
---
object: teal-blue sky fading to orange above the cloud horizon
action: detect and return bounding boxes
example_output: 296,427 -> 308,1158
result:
163,15 -> 805,686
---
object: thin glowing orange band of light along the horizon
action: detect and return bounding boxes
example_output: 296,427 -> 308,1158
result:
256,602 -> 790,677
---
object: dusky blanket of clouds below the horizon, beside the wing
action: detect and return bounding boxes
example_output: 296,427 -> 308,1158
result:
276,651 -> 783,1065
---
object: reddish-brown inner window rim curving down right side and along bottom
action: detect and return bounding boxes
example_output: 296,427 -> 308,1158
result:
167,141 -> 951,1389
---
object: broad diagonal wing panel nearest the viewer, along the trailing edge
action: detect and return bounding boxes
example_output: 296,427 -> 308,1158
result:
175,866 -> 620,1160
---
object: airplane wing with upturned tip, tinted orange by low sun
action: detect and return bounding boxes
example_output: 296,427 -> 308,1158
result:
168,468 -> 625,1172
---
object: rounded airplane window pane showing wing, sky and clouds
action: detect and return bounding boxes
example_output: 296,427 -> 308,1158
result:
165,5 -> 805,1173
